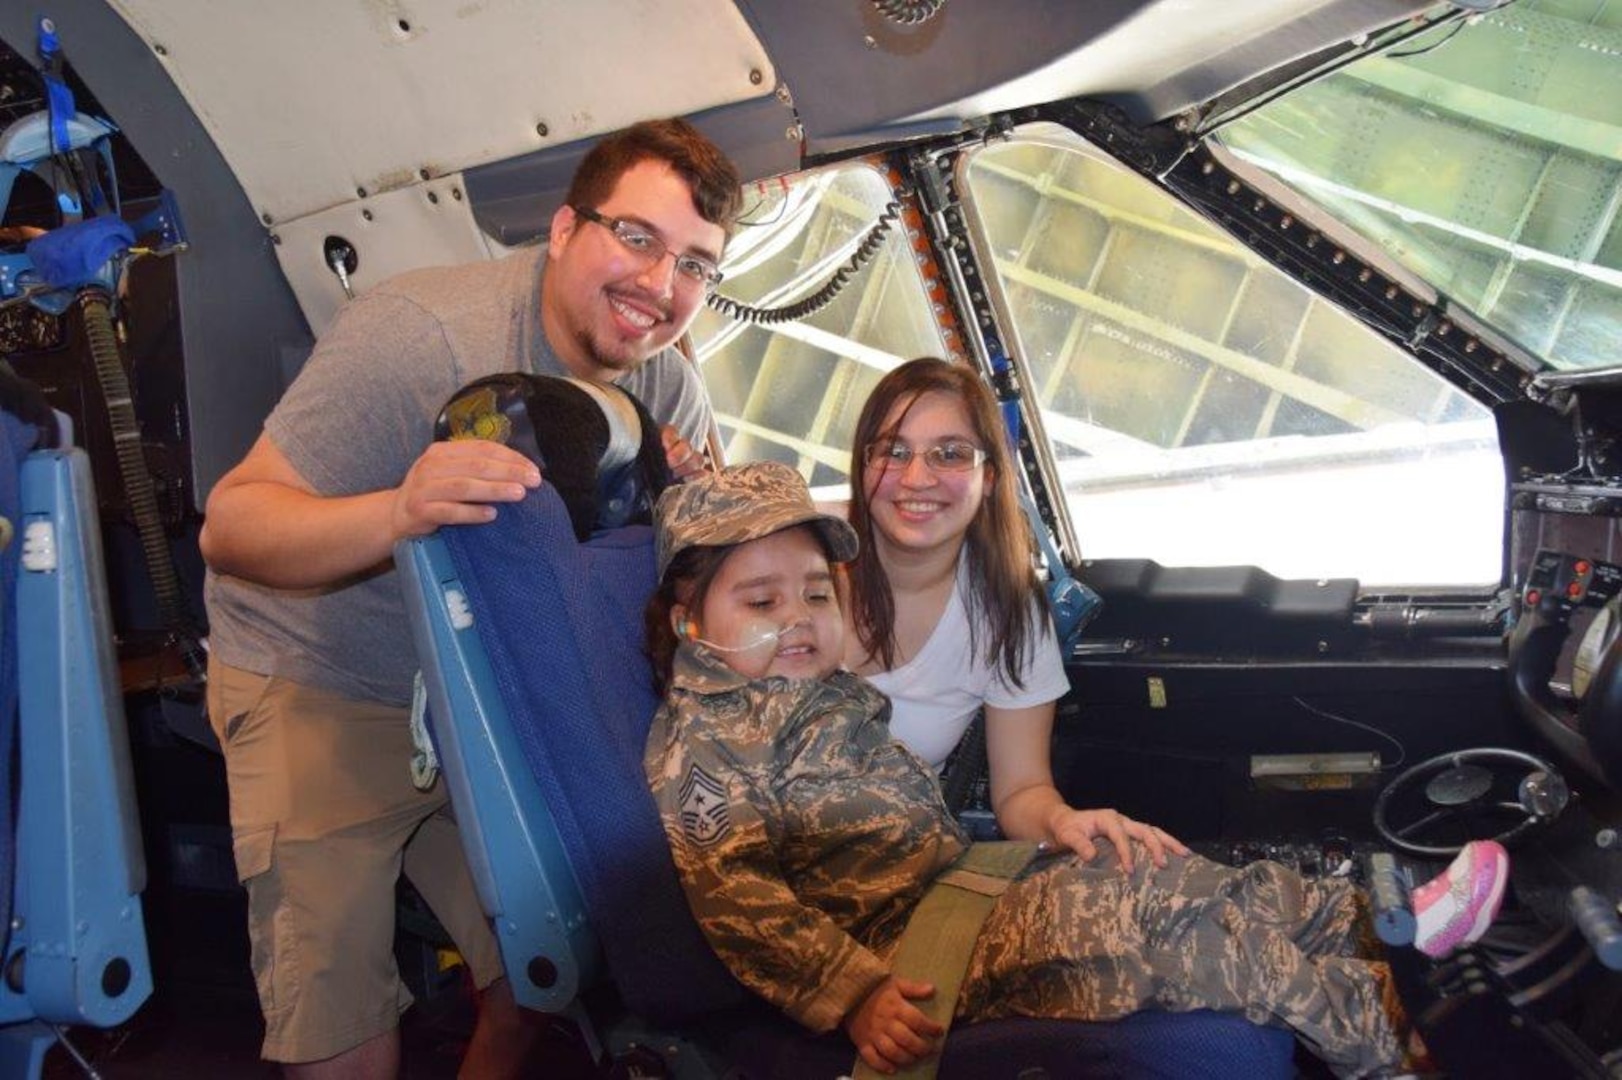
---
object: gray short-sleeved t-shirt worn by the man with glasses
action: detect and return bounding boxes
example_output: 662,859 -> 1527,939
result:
204,248 -> 710,705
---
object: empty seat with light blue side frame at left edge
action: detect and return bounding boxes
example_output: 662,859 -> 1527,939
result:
0,398 -> 152,1077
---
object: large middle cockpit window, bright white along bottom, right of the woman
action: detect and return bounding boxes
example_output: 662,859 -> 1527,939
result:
962,126 -> 1504,589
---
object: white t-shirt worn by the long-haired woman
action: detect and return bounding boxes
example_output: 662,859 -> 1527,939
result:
866,559 -> 1071,769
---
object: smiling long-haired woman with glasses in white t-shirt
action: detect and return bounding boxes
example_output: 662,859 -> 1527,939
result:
845,358 -> 1187,868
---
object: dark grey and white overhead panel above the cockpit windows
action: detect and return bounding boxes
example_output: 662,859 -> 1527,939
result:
740,0 -> 1429,154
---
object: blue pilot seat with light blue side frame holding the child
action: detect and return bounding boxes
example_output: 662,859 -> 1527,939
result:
396,485 -> 1293,1078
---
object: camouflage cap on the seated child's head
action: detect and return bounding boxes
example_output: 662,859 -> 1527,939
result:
654,461 -> 861,581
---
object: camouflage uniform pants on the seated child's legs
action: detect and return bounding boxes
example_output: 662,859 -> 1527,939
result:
957,842 -> 1401,1077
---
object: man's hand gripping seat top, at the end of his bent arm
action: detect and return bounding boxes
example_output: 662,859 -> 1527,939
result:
393,439 -> 540,537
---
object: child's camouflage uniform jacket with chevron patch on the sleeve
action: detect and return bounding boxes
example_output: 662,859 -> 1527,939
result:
644,644 -> 967,1031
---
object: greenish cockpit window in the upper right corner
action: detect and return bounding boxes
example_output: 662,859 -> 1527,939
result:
1215,0 -> 1622,370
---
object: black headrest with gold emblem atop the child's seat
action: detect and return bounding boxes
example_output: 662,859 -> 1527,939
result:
433,371 -> 672,540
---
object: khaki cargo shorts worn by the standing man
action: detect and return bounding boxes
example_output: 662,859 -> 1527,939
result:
208,658 -> 501,1062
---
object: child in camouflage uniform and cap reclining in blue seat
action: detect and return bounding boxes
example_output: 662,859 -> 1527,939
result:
646,464 -> 1401,1075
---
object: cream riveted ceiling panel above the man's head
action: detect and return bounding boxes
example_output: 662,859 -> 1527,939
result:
112,0 -> 777,224
